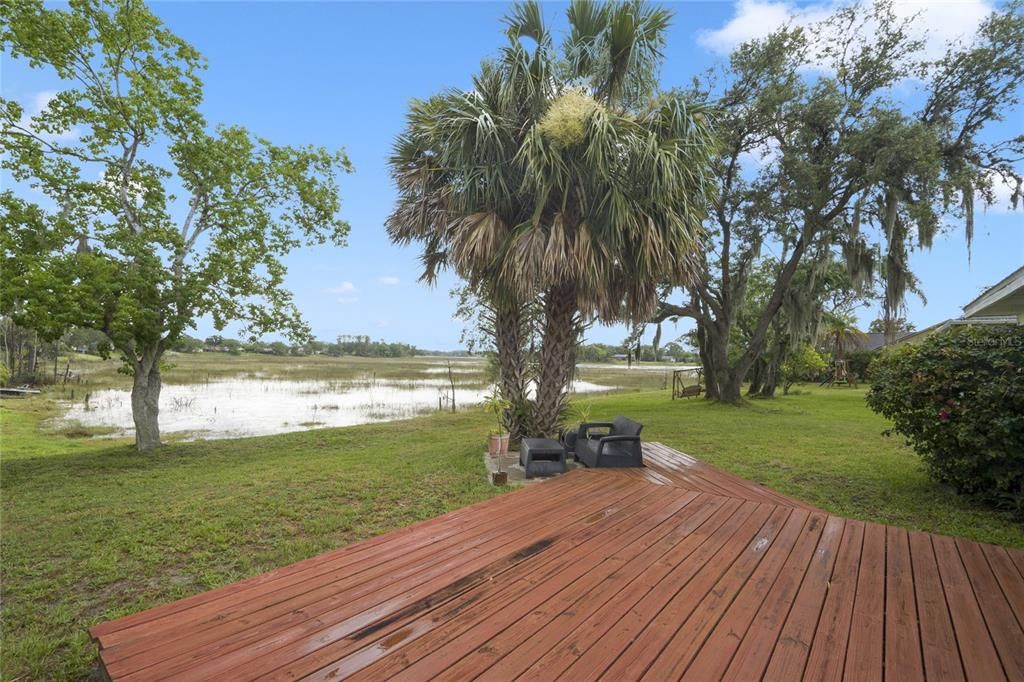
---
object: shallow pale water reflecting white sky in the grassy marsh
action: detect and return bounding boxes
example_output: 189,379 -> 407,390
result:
62,369 -> 612,438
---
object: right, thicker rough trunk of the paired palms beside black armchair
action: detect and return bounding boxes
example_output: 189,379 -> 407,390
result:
534,284 -> 581,436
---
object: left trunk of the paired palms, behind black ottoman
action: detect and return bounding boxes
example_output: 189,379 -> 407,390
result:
495,302 -> 530,440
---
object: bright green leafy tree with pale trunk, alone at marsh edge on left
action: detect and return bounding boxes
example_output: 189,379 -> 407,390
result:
0,0 -> 350,450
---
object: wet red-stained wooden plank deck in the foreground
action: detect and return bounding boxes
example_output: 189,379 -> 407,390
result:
91,445 -> 1024,682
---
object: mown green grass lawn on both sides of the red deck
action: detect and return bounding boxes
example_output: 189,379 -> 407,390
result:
0,389 -> 1024,680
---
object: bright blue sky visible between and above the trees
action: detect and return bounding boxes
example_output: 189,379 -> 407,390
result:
2,0 -> 1024,349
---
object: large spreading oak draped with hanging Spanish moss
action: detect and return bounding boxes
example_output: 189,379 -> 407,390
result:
654,0 -> 1024,401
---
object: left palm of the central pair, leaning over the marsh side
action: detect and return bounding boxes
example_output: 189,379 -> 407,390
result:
386,29 -> 547,439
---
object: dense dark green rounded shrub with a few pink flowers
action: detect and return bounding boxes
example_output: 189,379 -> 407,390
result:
867,325 -> 1024,513
